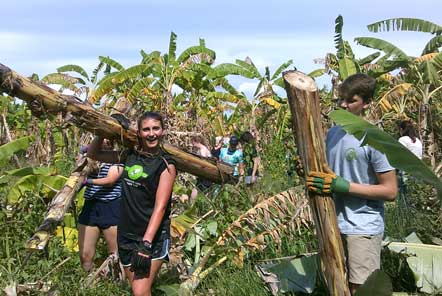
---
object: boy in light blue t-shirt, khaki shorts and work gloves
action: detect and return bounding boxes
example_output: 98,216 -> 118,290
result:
307,74 -> 397,294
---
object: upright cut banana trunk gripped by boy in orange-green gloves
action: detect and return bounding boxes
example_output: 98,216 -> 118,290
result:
283,71 -> 350,296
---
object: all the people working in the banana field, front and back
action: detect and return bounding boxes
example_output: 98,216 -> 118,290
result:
79,74 -> 422,295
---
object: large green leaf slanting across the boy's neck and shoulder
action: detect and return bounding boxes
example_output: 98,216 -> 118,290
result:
330,110 -> 442,197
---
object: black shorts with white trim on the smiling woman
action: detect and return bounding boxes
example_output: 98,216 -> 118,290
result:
118,230 -> 170,267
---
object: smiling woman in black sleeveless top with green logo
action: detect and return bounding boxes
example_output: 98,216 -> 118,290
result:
88,112 -> 176,296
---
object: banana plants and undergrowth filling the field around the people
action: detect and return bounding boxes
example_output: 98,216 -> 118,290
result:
0,16 -> 442,296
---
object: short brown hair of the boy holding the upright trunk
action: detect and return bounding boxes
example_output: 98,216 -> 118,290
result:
339,73 -> 376,103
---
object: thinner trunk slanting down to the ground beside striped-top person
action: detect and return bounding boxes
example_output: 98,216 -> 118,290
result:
25,157 -> 91,250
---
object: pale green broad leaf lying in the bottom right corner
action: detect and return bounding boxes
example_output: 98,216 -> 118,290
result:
387,242 -> 442,295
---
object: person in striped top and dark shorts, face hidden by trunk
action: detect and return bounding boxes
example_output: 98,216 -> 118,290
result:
78,142 -> 123,272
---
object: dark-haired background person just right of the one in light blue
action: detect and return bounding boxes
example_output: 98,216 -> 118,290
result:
239,132 -> 261,185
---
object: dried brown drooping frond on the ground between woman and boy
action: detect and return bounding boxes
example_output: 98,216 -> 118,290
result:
180,187 -> 312,295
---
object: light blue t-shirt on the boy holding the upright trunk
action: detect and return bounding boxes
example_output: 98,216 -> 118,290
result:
327,126 -> 394,235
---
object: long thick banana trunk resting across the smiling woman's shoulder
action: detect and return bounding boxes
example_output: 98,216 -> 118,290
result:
0,64 -> 236,183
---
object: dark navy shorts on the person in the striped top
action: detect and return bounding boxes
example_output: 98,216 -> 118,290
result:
78,198 -> 121,229
